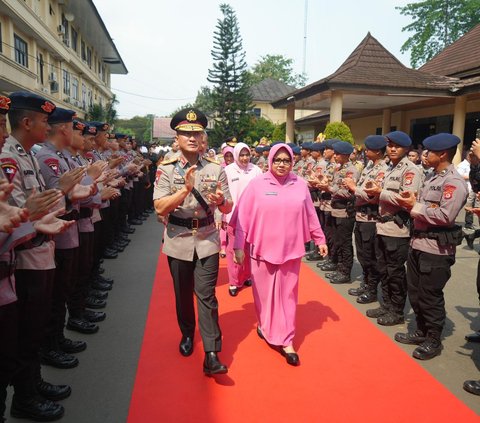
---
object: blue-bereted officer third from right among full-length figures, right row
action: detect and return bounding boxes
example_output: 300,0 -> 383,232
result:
345,135 -> 387,304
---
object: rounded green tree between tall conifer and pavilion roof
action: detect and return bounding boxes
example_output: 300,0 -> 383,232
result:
249,54 -> 307,88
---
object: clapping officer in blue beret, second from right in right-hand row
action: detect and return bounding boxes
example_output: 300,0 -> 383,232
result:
364,131 -> 422,326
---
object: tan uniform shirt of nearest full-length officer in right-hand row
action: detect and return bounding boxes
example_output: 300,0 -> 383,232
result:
410,164 -> 468,255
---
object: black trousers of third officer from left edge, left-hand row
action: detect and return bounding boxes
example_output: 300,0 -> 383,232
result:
46,247 -> 79,349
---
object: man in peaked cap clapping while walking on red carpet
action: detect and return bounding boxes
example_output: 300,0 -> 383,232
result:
154,109 -> 232,375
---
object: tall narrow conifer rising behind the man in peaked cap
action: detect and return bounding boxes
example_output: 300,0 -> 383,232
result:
207,4 -> 252,145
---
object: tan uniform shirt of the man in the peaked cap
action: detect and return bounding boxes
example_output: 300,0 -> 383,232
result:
153,155 -> 231,261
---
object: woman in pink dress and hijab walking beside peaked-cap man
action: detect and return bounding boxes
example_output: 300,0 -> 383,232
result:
230,143 -> 328,366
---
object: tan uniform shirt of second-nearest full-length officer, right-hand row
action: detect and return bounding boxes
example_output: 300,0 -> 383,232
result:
377,156 -> 422,238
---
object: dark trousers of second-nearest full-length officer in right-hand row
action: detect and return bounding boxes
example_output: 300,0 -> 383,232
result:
375,235 -> 410,315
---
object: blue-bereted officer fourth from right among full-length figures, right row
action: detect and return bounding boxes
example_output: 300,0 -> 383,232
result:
325,141 -> 359,283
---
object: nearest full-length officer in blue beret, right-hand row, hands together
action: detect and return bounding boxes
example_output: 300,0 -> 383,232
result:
395,133 -> 468,360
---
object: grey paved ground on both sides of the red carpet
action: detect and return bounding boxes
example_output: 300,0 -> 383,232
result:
7,216 -> 480,423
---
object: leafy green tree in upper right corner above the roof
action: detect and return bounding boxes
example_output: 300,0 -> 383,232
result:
396,0 -> 480,68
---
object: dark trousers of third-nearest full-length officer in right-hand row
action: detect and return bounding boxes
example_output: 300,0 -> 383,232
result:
355,221 -> 380,293
